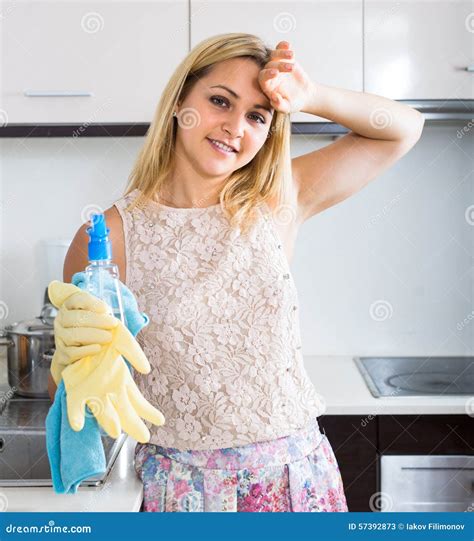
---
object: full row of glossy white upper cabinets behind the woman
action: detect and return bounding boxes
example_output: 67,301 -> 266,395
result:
0,0 -> 468,125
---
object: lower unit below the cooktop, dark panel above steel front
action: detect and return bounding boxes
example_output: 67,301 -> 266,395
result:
378,415 -> 474,512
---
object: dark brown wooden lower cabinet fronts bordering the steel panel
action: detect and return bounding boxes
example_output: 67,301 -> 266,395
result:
318,415 -> 474,511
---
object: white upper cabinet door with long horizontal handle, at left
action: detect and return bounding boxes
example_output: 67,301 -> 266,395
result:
0,0 -> 188,124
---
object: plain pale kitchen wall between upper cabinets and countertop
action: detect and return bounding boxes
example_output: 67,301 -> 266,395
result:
0,121 -> 474,355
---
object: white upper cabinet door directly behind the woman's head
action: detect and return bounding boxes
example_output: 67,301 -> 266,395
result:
191,0 -> 362,122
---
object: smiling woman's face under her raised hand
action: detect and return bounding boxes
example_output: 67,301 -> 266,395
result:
176,58 -> 273,177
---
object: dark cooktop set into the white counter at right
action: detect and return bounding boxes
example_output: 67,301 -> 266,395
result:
354,357 -> 474,398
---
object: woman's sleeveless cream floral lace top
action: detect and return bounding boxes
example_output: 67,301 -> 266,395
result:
115,190 -> 325,450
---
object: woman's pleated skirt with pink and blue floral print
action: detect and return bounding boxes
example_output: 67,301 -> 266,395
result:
135,419 -> 348,512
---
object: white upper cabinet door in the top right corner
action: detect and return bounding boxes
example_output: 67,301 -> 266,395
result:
364,0 -> 474,100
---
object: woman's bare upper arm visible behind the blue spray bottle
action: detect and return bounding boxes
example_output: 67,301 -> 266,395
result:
63,205 -> 127,283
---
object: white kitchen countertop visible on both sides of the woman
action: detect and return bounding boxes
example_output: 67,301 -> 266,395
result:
0,356 -> 469,512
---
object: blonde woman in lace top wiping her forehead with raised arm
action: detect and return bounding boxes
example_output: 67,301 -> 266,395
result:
50,33 -> 423,512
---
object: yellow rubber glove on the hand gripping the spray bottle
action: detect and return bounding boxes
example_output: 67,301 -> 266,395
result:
48,280 -> 119,385
